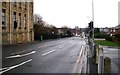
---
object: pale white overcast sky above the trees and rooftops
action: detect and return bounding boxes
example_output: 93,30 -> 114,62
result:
34,0 -> 120,28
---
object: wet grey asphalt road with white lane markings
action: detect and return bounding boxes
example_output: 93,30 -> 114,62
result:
0,37 -> 86,73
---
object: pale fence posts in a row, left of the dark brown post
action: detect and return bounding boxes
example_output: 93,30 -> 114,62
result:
88,38 -> 104,75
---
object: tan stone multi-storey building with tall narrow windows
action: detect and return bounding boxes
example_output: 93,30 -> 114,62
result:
0,0 -> 34,44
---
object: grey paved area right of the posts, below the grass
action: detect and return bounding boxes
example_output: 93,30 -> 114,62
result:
102,46 -> 120,75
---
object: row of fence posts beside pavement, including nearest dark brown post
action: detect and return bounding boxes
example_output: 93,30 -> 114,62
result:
87,38 -> 111,75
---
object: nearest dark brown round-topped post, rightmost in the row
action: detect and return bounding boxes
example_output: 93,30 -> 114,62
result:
104,57 -> 111,75
